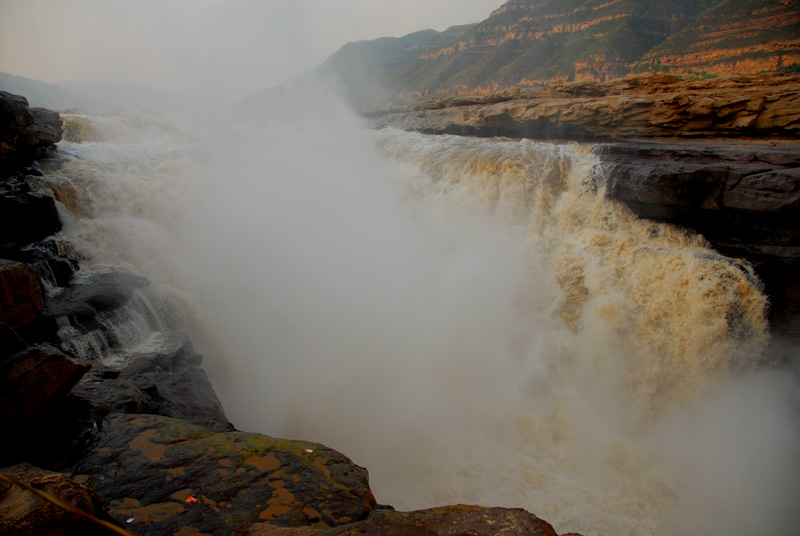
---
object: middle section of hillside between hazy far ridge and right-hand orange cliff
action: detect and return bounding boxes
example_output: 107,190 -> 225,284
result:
391,0 -> 705,93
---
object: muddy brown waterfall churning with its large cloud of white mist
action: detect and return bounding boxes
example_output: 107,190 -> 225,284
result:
36,105 -> 800,536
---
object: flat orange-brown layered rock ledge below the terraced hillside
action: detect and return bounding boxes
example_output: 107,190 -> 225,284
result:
372,75 -> 800,141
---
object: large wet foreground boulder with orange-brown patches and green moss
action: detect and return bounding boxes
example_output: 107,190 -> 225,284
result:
68,415 -> 375,535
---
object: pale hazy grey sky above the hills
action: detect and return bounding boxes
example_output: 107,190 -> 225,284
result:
0,0 -> 504,99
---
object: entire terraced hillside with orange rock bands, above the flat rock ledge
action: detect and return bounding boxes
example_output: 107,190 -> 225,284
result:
256,0 -> 800,110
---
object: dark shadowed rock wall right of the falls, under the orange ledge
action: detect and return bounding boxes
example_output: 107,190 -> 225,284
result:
594,141 -> 800,247
